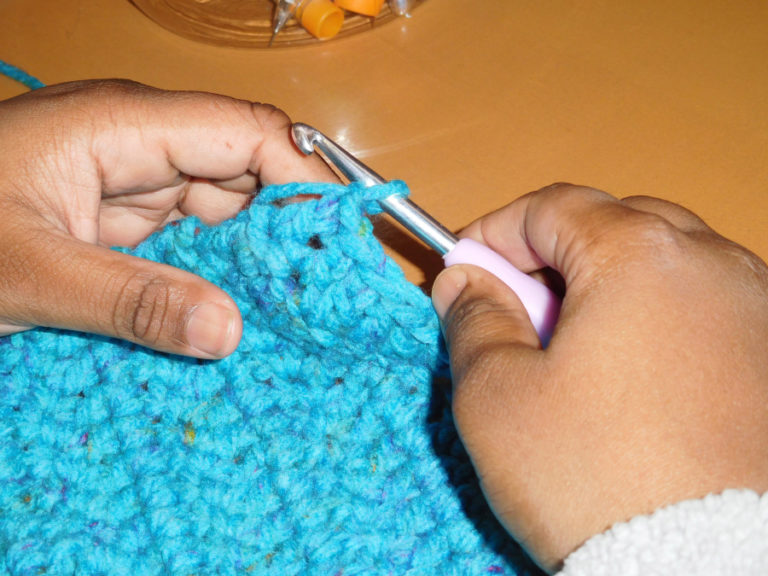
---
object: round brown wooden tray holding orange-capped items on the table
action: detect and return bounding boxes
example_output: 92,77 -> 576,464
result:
130,0 -> 424,48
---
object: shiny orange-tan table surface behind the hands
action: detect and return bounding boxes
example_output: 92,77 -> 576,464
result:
0,0 -> 768,282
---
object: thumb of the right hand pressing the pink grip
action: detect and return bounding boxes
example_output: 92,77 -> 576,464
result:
432,265 -> 549,528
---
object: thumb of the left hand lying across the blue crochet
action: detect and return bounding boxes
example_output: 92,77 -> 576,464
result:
0,234 -> 242,358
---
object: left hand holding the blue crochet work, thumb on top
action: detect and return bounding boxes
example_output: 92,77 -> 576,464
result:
0,81 -> 336,358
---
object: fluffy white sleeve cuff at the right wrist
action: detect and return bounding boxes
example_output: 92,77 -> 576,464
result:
558,490 -> 768,576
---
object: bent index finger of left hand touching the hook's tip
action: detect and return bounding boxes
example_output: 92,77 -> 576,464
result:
85,85 -> 336,193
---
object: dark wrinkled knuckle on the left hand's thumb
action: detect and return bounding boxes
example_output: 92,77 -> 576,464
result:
112,272 -> 183,345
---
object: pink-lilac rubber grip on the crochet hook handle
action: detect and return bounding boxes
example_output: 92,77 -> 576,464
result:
443,238 -> 560,348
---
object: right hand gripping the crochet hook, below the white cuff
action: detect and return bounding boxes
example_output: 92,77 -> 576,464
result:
433,185 -> 768,572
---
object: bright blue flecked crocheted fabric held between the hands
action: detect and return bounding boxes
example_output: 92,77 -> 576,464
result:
0,184 -> 535,576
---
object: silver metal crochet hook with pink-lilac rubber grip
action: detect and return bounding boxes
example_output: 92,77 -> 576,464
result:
291,122 -> 560,347
